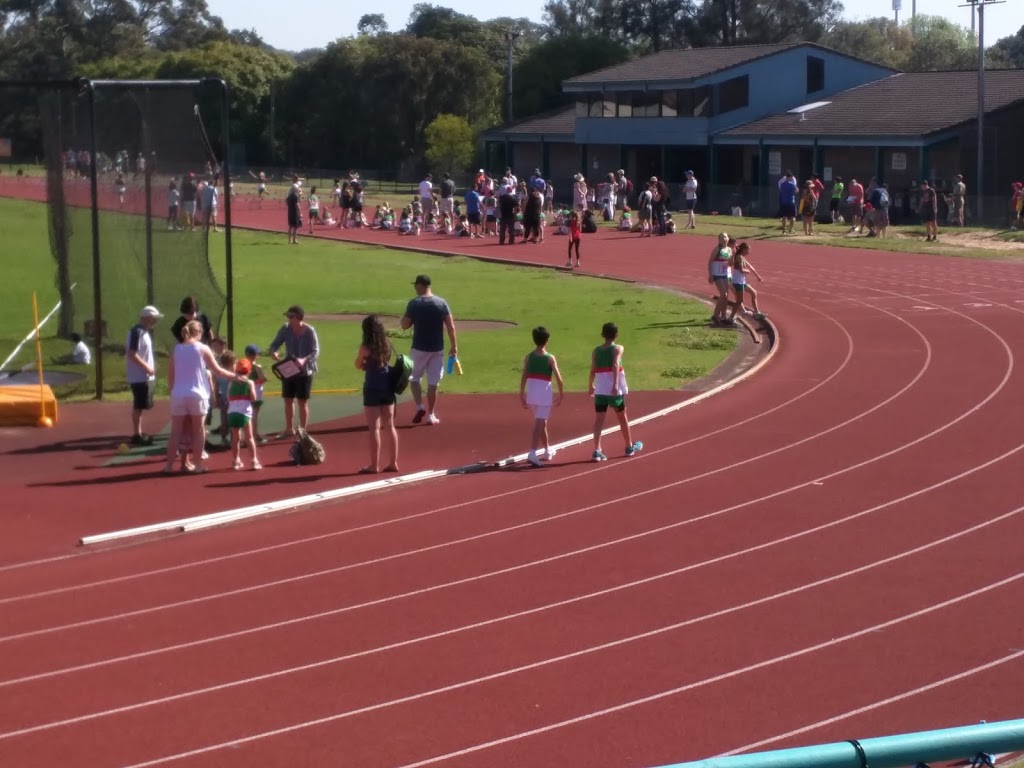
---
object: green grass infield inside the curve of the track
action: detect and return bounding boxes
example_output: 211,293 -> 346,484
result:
0,200 -> 736,398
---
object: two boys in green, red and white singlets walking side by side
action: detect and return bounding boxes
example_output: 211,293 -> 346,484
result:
519,323 -> 643,467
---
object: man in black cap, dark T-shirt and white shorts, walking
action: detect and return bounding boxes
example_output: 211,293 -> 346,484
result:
401,274 -> 459,425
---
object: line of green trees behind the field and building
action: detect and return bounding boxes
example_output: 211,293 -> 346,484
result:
0,0 -> 1024,173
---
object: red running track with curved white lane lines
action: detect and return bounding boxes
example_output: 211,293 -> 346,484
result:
0,185 -> 1024,768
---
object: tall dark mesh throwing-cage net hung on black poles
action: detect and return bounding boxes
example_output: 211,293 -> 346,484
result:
0,79 -> 233,398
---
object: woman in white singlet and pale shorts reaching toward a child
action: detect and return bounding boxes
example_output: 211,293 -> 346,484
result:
164,321 -> 245,474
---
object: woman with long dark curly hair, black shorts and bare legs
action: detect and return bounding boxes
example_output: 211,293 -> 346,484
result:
355,314 -> 398,475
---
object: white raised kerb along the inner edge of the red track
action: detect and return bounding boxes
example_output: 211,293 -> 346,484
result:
79,231 -> 780,546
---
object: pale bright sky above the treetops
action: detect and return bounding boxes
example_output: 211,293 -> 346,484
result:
207,0 -> 1024,51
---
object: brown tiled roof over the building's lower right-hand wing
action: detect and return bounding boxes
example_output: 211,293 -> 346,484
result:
720,70 -> 1024,137
